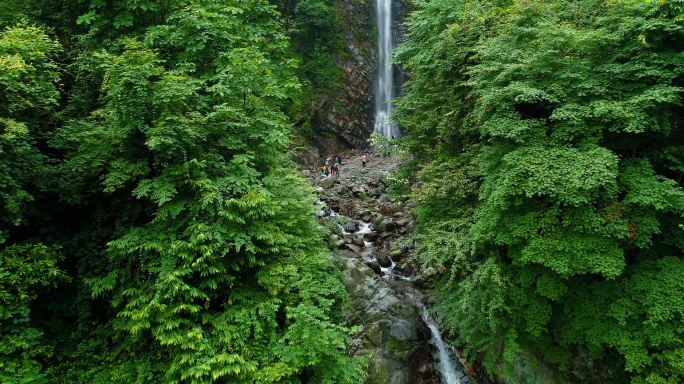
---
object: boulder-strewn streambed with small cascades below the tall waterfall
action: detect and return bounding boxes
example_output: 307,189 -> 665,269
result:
305,151 -> 475,384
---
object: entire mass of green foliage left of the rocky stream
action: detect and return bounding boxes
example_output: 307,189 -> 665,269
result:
0,0 -> 363,383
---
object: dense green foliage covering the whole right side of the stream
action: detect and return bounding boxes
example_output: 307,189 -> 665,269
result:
397,0 -> 684,383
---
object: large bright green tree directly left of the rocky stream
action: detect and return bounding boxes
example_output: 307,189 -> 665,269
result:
46,0 -> 362,383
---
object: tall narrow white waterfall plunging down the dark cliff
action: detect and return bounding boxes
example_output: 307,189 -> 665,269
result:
374,0 -> 399,138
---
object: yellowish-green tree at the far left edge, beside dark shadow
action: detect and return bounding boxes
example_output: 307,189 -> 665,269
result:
0,25 -> 60,244
